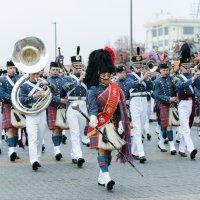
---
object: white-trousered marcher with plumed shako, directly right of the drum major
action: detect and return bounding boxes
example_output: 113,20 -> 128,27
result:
129,47 -> 153,163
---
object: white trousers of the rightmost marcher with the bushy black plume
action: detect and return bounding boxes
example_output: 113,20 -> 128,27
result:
178,100 -> 194,153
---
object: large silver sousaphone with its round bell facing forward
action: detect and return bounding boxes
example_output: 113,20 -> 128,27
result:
11,37 -> 52,115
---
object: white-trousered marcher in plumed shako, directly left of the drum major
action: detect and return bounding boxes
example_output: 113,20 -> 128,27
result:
63,47 -> 89,167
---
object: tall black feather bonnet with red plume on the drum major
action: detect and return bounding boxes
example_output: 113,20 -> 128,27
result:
85,47 -> 115,87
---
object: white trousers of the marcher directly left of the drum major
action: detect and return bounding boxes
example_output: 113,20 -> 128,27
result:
67,100 -> 87,159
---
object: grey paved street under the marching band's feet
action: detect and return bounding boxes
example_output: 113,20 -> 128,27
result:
0,123 -> 200,200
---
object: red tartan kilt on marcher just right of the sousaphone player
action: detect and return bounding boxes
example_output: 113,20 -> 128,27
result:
47,106 -> 59,130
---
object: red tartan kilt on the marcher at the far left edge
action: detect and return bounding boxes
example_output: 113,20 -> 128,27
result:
2,103 -> 14,129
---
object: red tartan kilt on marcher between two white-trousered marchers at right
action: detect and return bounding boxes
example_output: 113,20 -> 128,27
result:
156,102 -> 169,128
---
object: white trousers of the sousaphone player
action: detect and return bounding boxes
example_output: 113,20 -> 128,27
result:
26,110 -> 47,164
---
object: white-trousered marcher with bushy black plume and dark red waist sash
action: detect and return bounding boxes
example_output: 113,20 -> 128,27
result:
176,43 -> 200,159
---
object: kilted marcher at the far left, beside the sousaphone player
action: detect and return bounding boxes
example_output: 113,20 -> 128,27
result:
0,61 -> 20,162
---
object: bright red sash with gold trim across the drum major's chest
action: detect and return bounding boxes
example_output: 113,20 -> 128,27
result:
88,83 -> 120,136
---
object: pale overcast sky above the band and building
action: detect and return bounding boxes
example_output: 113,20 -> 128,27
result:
0,0 -> 195,65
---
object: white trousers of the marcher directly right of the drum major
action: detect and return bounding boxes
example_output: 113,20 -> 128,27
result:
130,97 -> 147,157
